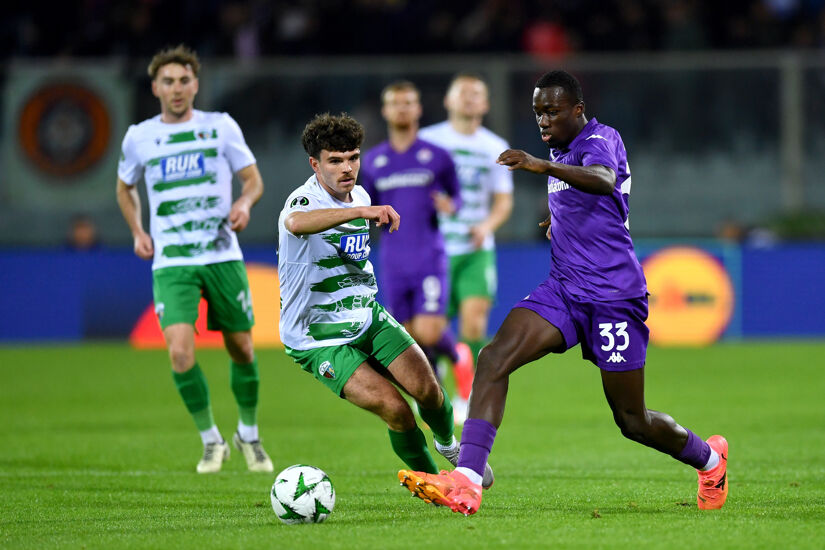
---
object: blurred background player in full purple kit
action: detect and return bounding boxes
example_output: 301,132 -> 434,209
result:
361,81 -> 473,422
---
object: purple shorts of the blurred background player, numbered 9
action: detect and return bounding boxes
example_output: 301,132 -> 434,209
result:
381,270 -> 450,323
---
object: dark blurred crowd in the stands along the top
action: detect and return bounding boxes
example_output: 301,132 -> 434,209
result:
0,0 -> 825,59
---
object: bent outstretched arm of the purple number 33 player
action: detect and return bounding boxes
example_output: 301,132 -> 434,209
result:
496,149 -> 616,195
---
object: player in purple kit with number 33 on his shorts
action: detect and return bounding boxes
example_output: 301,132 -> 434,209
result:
398,71 -> 728,515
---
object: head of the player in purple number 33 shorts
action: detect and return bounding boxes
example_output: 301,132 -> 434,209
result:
533,86 -> 584,147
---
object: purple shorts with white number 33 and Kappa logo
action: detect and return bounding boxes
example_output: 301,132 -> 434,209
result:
514,277 -> 650,371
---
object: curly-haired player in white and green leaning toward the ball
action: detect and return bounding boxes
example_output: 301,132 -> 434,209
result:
278,114 -> 492,486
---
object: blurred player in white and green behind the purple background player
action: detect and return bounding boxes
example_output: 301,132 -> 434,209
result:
419,74 -> 513,418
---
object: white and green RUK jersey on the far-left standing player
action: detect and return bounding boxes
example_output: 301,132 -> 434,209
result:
117,110 -> 255,269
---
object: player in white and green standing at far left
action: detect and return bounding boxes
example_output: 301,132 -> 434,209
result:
117,46 -> 272,473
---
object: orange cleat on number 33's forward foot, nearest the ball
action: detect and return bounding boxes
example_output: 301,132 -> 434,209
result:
398,470 -> 481,516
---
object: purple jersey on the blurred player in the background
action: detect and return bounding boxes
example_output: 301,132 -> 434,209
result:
360,139 -> 460,273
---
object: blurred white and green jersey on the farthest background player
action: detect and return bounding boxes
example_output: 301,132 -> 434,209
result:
418,120 -> 513,256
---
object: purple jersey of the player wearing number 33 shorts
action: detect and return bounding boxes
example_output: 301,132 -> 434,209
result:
547,118 -> 647,301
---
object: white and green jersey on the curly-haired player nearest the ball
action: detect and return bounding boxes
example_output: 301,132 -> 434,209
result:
278,175 -> 378,350
